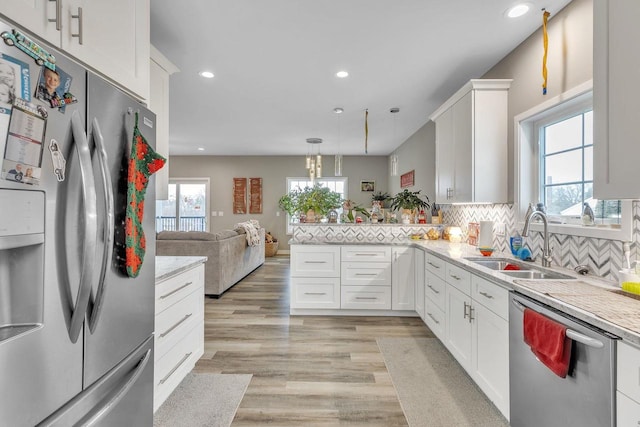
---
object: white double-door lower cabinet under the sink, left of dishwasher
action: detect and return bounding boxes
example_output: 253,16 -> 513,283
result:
445,264 -> 509,419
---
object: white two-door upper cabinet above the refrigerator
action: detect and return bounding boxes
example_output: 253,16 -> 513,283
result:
0,0 -> 150,102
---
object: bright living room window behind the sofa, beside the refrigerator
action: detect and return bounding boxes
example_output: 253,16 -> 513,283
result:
156,178 -> 209,232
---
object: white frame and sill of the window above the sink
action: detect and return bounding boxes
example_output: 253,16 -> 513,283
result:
513,80 -> 633,241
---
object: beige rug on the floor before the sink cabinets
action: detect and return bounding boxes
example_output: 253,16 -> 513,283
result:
377,338 -> 509,427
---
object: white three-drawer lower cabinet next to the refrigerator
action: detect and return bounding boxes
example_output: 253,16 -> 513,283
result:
153,264 -> 204,412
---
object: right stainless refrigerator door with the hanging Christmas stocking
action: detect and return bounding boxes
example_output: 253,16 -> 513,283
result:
84,73 -> 155,387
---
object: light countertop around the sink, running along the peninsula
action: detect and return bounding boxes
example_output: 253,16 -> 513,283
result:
292,237 -> 640,346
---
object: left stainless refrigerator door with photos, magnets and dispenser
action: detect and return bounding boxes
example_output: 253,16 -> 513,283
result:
0,22 -> 86,426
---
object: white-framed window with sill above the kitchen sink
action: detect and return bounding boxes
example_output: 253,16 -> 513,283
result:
514,82 -> 631,240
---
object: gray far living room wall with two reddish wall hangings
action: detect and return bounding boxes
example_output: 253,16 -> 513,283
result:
169,155 -> 384,250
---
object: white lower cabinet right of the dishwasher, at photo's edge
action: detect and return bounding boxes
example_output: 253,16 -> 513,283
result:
616,341 -> 640,427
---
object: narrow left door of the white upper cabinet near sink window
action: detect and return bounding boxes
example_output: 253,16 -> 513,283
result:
436,109 -> 454,204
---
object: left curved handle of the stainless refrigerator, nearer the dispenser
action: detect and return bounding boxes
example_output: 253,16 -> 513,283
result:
69,111 -> 98,343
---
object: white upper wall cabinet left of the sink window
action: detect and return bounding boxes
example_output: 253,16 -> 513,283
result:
430,79 -> 511,204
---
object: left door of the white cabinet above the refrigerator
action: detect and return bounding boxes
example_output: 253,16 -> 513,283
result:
0,0 -> 62,47
